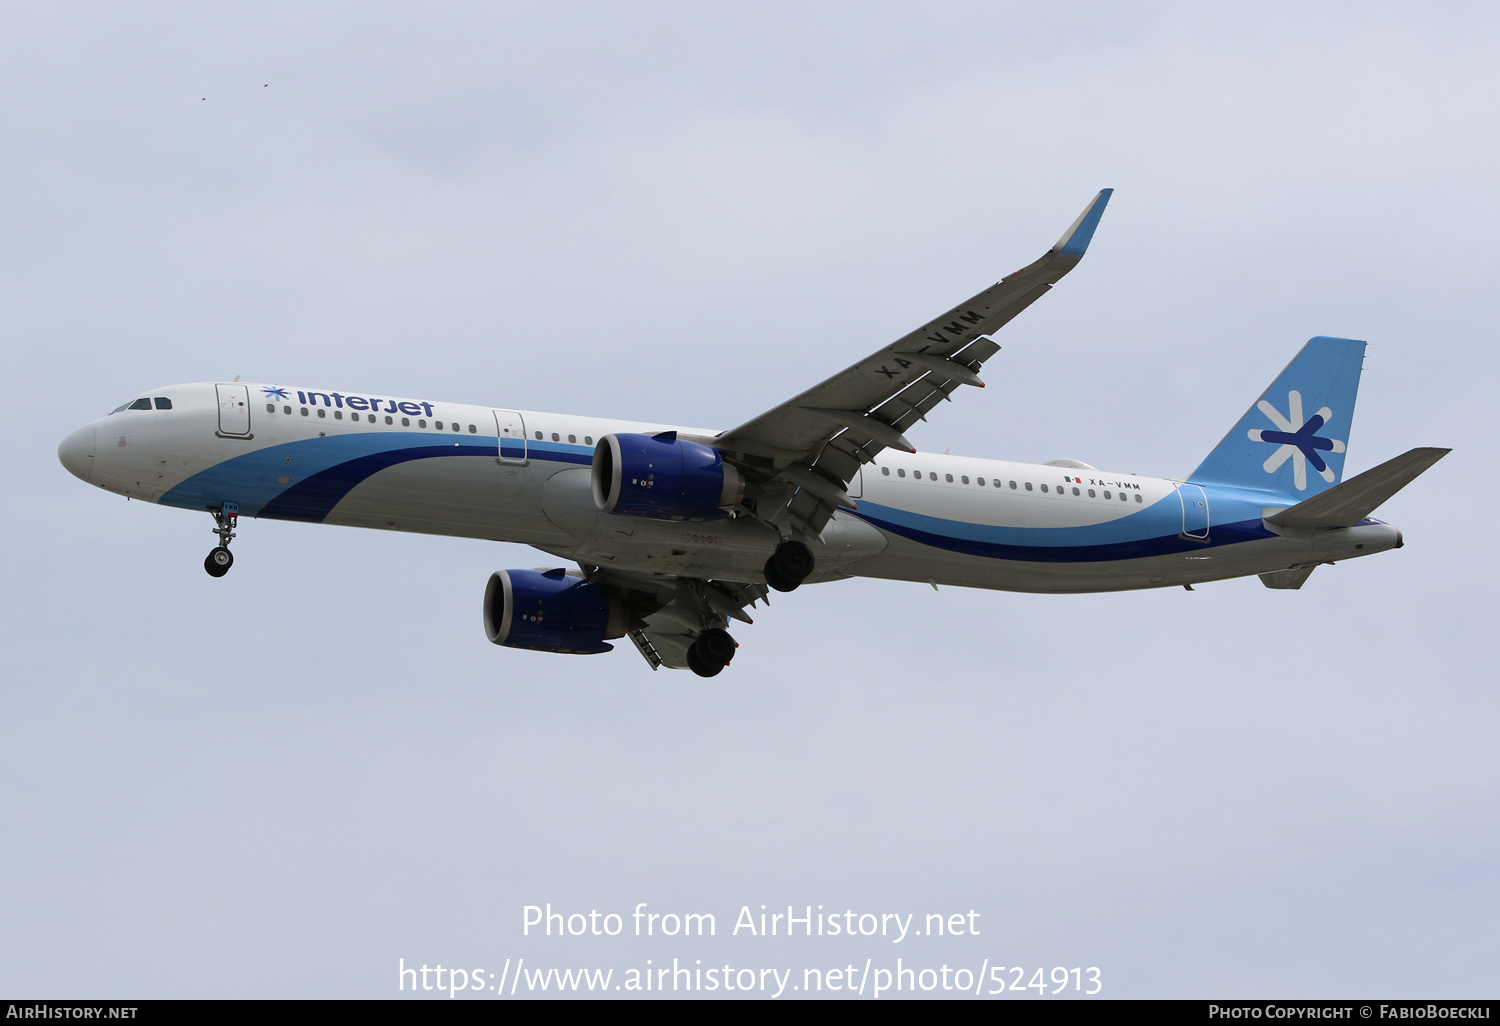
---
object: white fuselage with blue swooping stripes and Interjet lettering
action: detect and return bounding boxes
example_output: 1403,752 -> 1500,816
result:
60,383 -> 1400,593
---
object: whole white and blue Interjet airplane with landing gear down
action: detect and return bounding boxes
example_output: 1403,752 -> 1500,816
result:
59,189 -> 1451,677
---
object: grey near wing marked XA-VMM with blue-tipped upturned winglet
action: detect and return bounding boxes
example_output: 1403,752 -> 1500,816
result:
713,189 -> 1113,537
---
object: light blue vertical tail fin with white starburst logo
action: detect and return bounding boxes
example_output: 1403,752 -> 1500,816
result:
1188,335 -> 1365,500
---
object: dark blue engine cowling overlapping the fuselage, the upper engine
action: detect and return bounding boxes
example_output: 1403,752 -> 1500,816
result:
593,431 -> 744,521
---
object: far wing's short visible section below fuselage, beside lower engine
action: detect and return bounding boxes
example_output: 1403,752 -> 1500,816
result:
584,566 -> 770,669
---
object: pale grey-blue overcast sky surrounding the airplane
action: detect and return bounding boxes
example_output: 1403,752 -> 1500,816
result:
0,0 -> 1500,998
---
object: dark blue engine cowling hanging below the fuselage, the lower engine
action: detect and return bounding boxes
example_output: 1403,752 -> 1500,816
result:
485,570 -> 629,656
